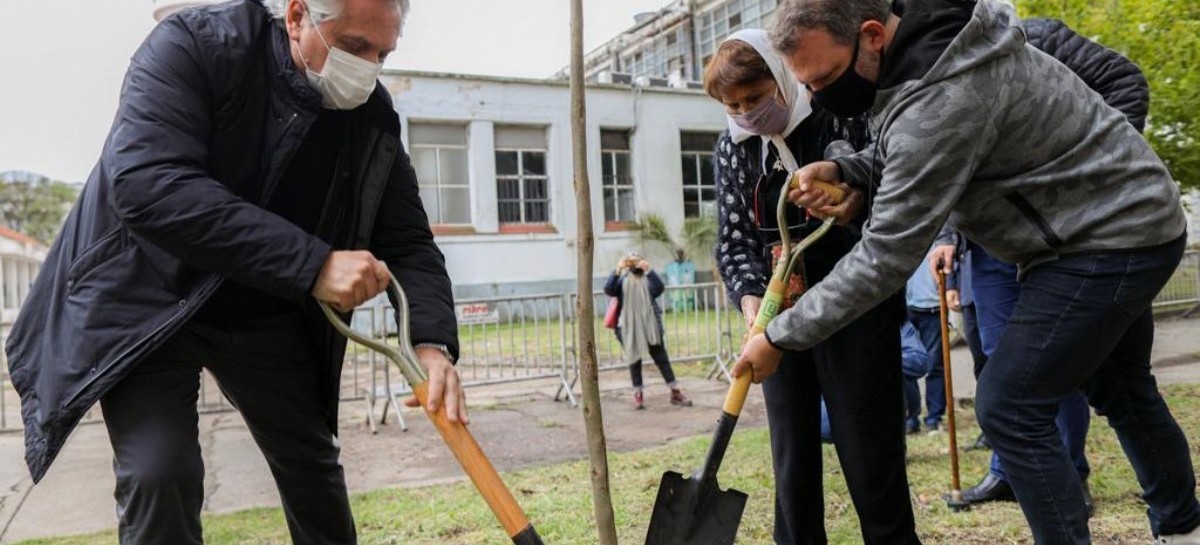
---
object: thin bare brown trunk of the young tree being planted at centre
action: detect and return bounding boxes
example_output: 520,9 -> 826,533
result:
571,0 -> 617,545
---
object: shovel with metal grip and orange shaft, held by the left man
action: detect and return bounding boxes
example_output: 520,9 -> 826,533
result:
320,279 -> 545,545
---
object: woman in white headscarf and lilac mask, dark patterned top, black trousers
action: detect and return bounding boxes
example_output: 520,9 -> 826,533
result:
704,30 -> 920,545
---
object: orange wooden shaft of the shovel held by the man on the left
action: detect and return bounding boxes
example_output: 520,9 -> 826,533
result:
413,382 -> 530,538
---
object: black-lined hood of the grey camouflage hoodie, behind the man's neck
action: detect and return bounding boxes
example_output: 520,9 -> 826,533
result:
872,0 -> 1025,131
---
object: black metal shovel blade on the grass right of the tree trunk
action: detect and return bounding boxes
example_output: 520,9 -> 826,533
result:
646,472 -> 746,545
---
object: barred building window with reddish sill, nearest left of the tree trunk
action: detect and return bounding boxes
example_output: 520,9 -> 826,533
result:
496,127 -> 550,224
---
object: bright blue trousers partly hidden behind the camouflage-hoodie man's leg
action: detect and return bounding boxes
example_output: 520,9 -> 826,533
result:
964,247 -> 1092,480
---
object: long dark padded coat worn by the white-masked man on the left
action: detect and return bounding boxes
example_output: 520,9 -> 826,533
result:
6,0 -> 457,480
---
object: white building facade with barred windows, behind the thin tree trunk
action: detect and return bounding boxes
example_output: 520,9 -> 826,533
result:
383,72 -> 726,298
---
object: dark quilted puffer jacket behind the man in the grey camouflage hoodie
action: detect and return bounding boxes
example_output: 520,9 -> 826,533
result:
1022,18 -> 1150,132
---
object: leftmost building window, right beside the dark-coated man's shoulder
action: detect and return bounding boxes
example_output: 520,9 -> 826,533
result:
408,122 -> 470,226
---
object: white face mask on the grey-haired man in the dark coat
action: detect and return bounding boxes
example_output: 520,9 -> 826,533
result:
300,14 -> 383,109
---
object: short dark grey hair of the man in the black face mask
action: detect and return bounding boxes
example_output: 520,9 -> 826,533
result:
770,0 -> 892,55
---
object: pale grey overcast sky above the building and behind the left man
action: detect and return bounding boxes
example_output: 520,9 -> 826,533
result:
0,0 -> 668,181
